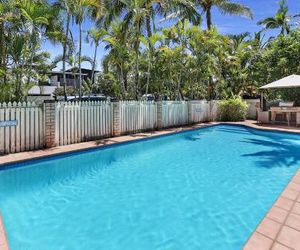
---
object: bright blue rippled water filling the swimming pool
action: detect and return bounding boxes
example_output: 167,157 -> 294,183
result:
0,125 -> 300,250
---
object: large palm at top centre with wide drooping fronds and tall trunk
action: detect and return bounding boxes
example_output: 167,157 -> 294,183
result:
108,0 -> 200,99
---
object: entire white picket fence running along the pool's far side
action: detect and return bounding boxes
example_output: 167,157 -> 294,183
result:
0,101 -> 223,155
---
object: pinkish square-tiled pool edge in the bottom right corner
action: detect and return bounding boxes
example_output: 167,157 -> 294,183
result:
243,169 -> 300,250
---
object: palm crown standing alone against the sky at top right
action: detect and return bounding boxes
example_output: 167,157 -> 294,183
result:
258,0 -> 299,35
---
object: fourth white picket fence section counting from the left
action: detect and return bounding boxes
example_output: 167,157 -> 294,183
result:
162,101 -> 188,128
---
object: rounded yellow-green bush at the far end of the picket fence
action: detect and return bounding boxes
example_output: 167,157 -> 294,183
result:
219,97 -> 248,122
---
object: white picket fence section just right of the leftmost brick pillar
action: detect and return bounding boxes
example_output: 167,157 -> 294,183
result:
55,101 -> 113,145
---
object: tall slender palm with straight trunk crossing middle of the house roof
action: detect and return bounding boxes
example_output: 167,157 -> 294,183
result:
74,0 -> 102,99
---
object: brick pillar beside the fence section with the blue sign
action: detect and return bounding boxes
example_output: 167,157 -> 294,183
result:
44,100 -> 56,148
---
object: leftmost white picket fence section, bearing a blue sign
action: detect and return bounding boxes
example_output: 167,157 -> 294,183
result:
0,102 -> 44,155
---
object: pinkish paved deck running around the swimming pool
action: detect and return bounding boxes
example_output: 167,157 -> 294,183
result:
0,120 -> 300,250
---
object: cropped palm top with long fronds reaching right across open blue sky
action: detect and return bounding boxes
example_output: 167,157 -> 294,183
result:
195,0 -> 253,30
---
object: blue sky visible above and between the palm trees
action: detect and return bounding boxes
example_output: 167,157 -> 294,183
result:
42,0 -> 300,70
